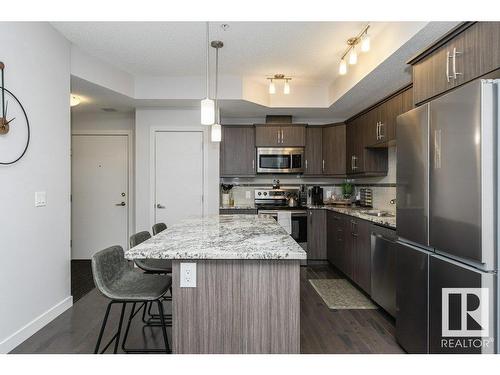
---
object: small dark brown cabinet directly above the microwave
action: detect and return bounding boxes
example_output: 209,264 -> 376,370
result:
255,124 -> 306,147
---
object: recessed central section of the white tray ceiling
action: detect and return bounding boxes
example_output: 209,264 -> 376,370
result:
52,22 -> 376,81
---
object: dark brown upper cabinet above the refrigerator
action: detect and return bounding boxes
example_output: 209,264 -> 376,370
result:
408,22 -> 500,104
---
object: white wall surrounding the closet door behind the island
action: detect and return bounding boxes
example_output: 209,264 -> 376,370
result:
135,109 -> 219,231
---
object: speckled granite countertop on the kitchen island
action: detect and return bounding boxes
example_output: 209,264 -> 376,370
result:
125,214 -> 306,259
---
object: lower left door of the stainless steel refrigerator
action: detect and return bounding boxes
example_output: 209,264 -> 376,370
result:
395,242 -> 429,354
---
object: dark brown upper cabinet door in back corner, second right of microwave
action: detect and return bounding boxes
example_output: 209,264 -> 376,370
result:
322,123 -> 346,176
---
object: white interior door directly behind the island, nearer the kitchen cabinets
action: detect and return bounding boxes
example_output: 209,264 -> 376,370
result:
155,131 -> 203,225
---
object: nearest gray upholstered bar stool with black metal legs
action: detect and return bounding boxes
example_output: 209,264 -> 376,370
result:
92,246 -> 172,354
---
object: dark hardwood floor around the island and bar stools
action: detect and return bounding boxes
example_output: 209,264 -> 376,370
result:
12,265 -> 403,354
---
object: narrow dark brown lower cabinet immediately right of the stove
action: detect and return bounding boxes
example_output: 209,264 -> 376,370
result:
307,210 -> 327,260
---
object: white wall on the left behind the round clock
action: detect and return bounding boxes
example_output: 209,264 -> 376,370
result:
0,22 -> 72,353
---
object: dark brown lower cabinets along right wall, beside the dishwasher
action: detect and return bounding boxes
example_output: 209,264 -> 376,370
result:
327,211 -> 371,294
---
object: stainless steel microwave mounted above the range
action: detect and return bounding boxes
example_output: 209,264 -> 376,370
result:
257,147 -> 304,173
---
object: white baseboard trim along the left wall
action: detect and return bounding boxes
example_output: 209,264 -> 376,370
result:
0,296 -> 73,354
